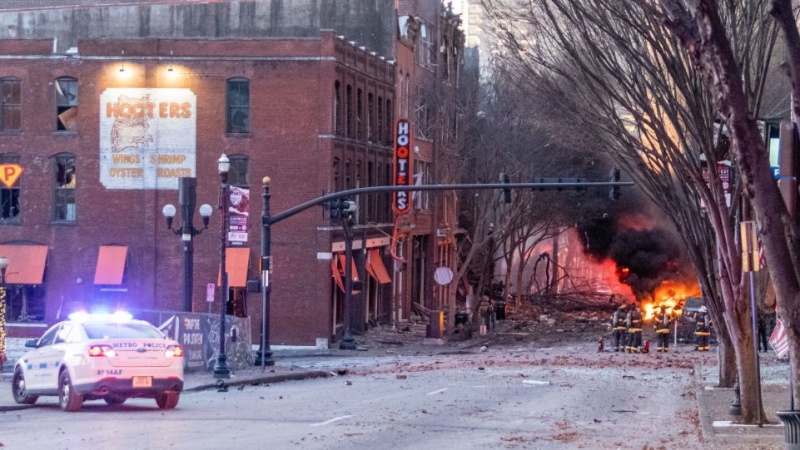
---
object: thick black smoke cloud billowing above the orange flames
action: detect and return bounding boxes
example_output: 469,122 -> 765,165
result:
578,217 -> 691,299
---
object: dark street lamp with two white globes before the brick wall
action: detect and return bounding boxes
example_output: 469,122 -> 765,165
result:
161,177 -> 212,312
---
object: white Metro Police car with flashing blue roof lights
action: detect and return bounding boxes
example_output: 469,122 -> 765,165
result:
11,314 -> 183,412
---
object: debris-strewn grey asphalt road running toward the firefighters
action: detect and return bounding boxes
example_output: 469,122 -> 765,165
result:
0,353 -> 704,450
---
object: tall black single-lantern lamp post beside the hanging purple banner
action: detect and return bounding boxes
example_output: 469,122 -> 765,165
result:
214,153 -> 231,378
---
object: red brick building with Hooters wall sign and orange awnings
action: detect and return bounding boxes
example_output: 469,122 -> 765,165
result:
0,0 -> 462,345
